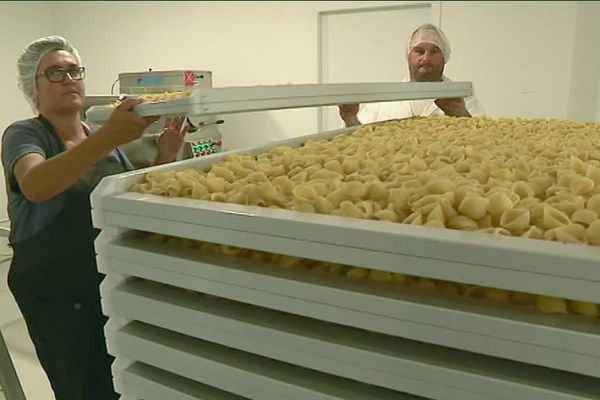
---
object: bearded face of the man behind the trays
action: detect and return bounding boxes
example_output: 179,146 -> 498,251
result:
408,43 -> 444,82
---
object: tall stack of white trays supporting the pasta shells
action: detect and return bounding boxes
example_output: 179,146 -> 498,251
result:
92,130 -> 600,400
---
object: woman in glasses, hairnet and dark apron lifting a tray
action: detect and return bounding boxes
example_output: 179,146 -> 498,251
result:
2,36 -> 185,400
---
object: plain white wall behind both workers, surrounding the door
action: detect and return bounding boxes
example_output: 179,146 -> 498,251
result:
0,1 -> 600,219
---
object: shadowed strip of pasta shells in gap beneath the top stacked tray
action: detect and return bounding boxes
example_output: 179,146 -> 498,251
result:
148,234 -> 600,317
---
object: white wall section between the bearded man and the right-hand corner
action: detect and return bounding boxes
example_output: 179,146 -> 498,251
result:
442,1 -> 578,118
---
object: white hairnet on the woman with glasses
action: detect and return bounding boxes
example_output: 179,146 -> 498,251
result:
17,36 -> 81,111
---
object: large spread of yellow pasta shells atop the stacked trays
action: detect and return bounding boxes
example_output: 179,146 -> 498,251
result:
131,117 -> 600,318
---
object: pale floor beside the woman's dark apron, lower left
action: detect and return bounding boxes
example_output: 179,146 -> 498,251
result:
0,238 -> 54,400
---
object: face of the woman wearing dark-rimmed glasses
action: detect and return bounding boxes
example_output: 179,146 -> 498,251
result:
36,50 -> 85,114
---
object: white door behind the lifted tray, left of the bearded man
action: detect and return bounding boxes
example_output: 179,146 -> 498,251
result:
318,2 -> 440,131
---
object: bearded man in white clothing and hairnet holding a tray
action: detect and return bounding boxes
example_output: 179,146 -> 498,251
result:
339,24 -> 484,127
